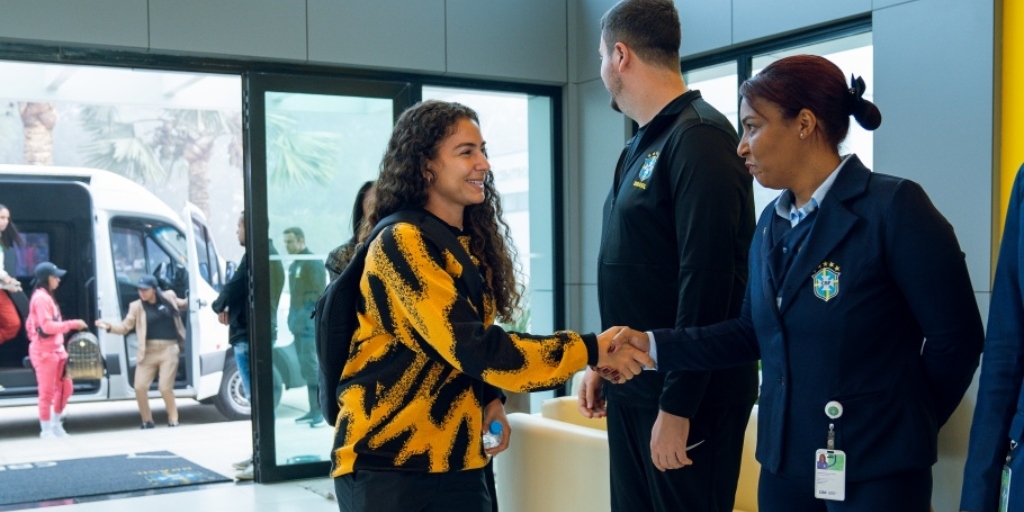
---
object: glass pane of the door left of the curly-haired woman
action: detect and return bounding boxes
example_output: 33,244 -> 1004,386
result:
257,92 -> 393,465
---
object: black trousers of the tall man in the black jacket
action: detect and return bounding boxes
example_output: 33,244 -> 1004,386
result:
607,400 -> 751,512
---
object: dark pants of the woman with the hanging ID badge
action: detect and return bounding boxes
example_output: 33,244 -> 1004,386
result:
758,466 -> 932,512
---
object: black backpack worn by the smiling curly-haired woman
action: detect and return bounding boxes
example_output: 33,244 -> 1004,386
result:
313,210 -> 483,425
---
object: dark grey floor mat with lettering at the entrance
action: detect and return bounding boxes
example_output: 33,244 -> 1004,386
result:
0,452 -> 231,505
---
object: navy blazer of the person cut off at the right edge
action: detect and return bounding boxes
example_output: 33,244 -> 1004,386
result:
961,167 -> 1024,511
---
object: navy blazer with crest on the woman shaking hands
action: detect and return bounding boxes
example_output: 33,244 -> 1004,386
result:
653,157 -> 984,481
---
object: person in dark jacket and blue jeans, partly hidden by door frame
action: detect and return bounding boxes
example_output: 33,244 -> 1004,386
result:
213,211 -> 253,480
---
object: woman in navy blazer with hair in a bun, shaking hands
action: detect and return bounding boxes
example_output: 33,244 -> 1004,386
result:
606,55 -> 983,512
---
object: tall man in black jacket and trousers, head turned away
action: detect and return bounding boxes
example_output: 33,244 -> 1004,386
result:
579,0 -> 761,512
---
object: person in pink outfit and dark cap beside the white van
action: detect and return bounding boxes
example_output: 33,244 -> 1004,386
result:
25,261 -> 87,437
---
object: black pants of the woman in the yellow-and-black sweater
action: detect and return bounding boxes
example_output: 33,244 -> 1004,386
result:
334,469 -> 492,512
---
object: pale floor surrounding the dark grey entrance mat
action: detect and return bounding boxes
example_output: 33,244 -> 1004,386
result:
0,399 -> 338,512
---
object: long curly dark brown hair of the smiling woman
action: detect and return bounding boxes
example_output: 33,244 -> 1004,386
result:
359,99 -> 521,323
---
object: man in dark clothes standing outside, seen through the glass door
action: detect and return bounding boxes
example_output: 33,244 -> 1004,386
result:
285,227 -> 327,427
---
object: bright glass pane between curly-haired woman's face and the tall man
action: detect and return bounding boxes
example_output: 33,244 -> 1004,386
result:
423,87 -> 555,412
